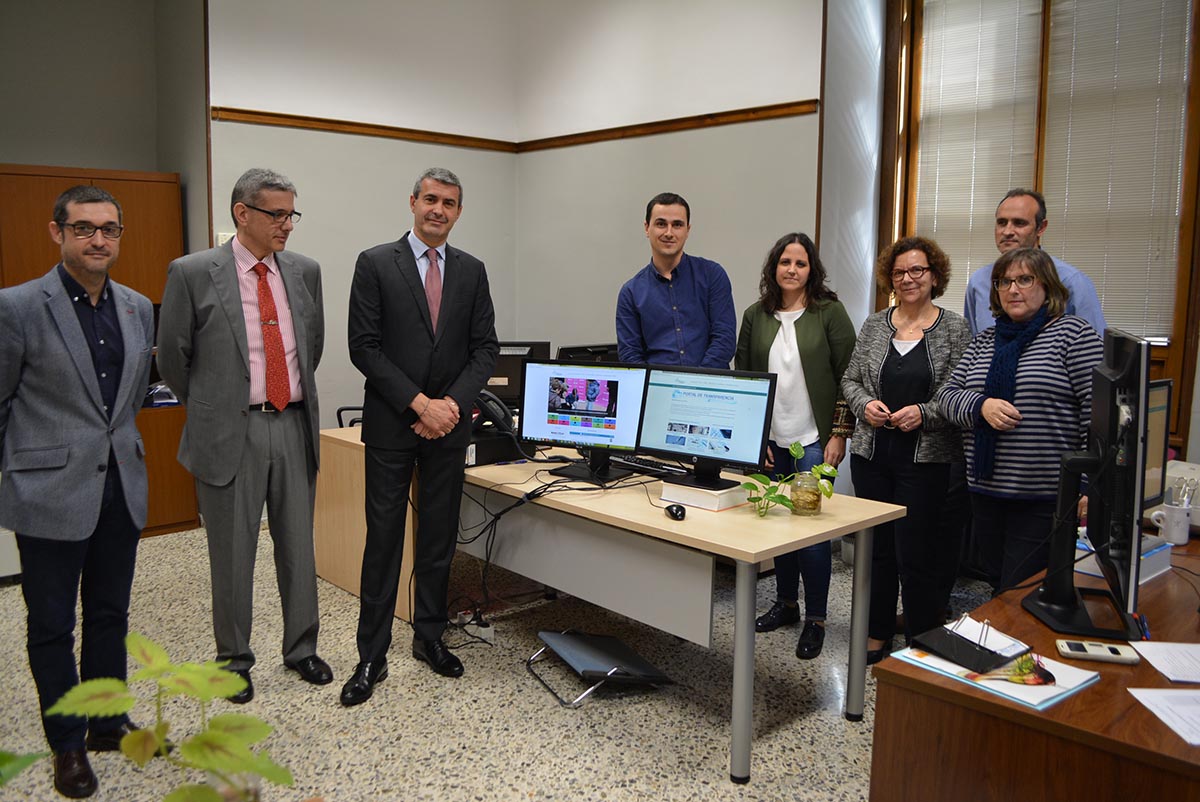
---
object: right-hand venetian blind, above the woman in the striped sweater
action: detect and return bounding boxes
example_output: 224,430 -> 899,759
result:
1042,0 -> 1192,339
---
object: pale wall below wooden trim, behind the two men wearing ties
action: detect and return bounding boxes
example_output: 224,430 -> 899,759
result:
212,122 -> 517,426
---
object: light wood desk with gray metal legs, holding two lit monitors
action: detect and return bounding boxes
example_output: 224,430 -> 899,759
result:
463,463 -> 905,783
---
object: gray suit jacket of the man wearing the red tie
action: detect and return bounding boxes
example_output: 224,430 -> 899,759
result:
158,243 -> 325,485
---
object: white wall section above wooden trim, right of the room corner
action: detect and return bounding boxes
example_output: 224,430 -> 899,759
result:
515,0 -> 838,140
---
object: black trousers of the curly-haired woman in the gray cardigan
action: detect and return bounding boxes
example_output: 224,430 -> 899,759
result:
851,450 -> 962,642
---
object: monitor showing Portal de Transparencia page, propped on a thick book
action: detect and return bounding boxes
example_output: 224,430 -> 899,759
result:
637,365 -> 775,490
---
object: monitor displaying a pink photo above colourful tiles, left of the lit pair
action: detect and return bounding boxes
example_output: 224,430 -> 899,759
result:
520,359 -> 646,484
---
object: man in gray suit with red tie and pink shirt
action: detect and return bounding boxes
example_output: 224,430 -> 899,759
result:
158,168 -> 334,704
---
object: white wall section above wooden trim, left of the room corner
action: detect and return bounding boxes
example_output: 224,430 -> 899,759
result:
209,0 -> 520,142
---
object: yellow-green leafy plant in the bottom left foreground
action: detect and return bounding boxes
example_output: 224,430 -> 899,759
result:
43,633 -> 293,802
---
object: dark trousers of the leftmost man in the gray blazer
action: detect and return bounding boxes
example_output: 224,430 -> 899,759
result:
17,460 -> 140,752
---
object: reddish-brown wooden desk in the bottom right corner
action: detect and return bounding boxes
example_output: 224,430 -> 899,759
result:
870,540 -> 1200,802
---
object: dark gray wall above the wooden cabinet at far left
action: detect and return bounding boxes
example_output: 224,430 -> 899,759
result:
0,0 -> 158,170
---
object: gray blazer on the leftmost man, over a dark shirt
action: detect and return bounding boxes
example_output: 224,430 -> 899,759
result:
0,268 -> 154,540
